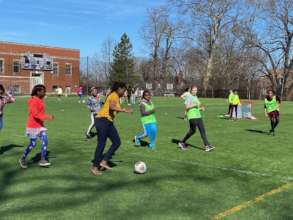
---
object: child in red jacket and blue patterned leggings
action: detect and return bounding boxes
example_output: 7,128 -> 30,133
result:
19,85 -> 54,169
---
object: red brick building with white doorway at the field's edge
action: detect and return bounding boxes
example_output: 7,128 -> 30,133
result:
0,41 -> 80,94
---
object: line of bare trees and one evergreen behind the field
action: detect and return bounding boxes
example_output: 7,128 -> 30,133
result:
83,0 -> 293,99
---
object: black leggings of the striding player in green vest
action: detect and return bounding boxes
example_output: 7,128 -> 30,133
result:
182,118 -> 209,146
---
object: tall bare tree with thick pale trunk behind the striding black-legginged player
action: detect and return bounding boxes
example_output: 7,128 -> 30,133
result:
171,0 -> 239,95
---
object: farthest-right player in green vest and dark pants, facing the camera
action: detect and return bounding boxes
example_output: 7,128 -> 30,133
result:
264,89 -> 281,135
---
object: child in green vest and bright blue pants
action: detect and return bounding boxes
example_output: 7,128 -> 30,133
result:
134,90 -> 157,149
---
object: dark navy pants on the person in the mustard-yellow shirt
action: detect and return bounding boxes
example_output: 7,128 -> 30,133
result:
93,118 -> 121,167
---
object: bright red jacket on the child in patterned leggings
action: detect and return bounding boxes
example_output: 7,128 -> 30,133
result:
26,96 -> 49,128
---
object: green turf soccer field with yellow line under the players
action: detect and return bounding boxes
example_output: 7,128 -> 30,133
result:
0,97 -> 293,220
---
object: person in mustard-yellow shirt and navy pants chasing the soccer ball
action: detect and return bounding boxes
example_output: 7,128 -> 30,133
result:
90,82 -> 133,176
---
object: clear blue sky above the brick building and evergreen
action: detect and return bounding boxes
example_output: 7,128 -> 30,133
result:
0,0 -> 165,57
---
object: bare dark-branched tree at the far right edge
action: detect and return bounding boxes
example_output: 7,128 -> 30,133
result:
238,0 -> 293,97
